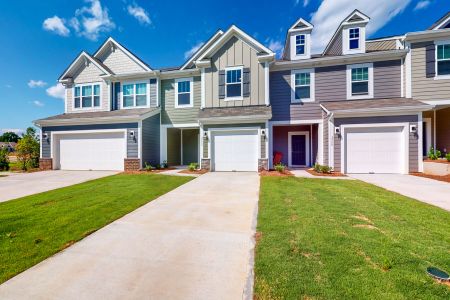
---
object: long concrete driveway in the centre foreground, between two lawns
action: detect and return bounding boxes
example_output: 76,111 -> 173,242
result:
0,173 -> 259,299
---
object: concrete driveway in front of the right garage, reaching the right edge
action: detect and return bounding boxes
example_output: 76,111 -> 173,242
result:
350,174 -> 450,211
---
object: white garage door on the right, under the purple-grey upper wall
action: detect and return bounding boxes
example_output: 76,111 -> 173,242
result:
344,127 -> 407,173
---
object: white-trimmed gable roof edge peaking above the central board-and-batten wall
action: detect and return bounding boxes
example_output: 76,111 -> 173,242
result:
197,25 -> 275,61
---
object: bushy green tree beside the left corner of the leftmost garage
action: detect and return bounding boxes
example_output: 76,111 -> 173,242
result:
16,127 -> 40,170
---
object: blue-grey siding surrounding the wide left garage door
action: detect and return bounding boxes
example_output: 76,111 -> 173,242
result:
42,123 -> 139,158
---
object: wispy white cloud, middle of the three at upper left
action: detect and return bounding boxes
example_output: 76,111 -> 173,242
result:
70,0 -> 116,41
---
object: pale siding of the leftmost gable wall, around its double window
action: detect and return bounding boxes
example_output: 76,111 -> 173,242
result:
66,63 -> 111,113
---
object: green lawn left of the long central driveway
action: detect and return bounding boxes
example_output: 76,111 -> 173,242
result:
0,174 -> 192,283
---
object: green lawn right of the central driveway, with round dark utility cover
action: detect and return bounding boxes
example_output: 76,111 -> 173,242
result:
255,177 -> 450,299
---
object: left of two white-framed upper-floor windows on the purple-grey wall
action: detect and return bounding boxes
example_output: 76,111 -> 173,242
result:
291,69 -> 314,102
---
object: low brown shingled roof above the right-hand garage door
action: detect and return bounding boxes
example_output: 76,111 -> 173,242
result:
320,98 -> 433,113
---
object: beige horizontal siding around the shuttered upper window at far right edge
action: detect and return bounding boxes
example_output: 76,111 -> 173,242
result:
411,41 -> 450,100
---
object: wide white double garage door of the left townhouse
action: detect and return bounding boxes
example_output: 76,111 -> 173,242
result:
55,132 -> 126,170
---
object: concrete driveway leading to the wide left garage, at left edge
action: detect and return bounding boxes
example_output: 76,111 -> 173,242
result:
0,171 -> 118,202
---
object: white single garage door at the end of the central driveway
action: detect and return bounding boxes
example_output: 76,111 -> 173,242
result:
211,130 -> 258,171
